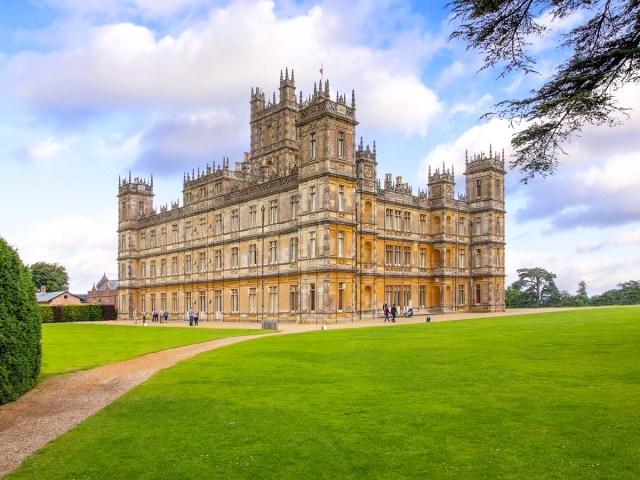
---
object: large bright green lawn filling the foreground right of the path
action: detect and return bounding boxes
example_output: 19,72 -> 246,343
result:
8,307 -> 640,480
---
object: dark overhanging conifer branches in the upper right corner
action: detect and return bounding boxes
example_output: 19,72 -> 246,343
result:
447,0 -> 640,183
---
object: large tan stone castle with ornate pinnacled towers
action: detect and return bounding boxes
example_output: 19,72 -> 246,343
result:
118,69 -> 505,323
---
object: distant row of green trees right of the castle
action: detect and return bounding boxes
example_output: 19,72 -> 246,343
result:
505,267 -> 640,308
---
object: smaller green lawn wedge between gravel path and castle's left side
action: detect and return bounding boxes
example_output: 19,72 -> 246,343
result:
42,323 -> 262,376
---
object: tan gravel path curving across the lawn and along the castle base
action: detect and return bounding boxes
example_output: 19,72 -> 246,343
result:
0,309 -> 558,476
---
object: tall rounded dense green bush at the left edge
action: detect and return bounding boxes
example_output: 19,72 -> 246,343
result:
0,238 -> 42,405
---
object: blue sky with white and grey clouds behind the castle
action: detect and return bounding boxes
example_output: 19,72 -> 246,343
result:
0,0 -> 640,294
